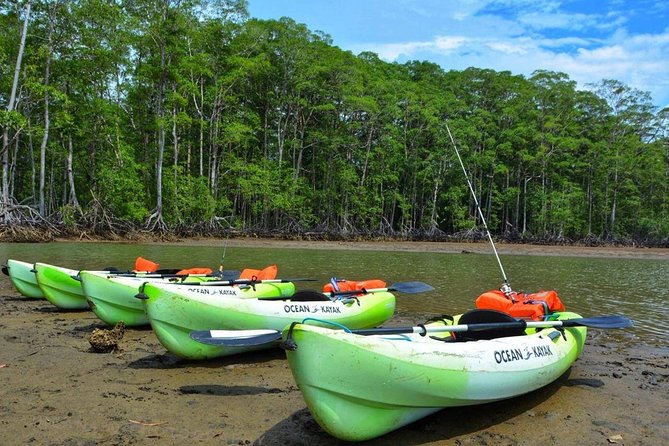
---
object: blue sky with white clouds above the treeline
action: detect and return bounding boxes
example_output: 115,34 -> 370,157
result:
249,0 -> 669,107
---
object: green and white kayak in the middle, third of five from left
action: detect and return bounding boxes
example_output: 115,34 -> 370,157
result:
79,271 -> 215,327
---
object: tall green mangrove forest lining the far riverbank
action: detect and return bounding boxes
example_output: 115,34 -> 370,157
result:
0,0 -> 669,243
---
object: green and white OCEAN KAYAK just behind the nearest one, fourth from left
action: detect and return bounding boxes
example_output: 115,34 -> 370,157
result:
143,283 -> 395,359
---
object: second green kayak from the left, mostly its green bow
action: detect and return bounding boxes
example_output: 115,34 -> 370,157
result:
35,263 -> 88,310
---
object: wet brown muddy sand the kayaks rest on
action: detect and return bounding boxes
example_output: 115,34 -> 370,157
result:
0,240 -> 669,446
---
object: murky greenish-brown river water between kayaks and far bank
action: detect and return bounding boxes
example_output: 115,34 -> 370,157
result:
0,240 -> 669,345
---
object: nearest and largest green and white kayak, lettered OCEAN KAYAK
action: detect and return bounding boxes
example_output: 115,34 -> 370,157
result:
284,312 -> 586,441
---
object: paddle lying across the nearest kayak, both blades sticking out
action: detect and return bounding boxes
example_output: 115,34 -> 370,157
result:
190,315 -> 633,347
